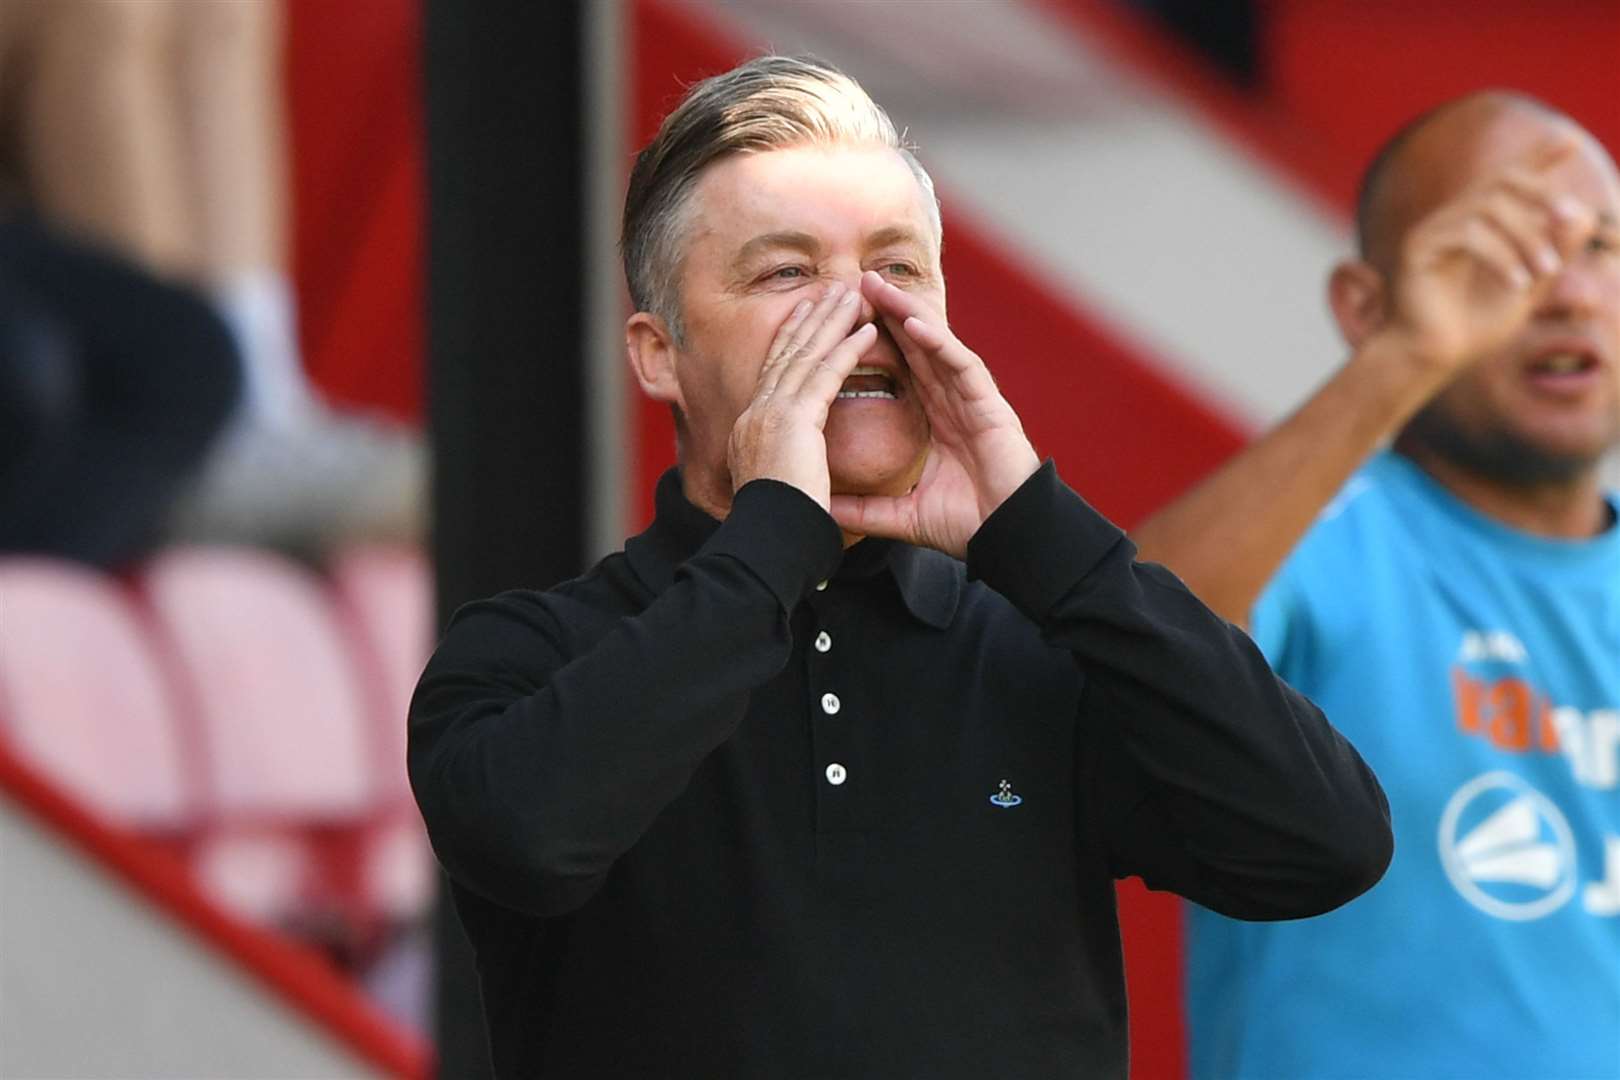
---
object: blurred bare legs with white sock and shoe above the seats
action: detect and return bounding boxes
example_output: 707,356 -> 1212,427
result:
0,0 -> 424,551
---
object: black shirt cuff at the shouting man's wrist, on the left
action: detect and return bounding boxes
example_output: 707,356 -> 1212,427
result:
695,479 -> 844,612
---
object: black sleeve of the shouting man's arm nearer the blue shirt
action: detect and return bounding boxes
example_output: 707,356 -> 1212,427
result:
969,463 -> 1392,918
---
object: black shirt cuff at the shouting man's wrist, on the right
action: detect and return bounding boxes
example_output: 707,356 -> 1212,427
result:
967,458 -> 1129,622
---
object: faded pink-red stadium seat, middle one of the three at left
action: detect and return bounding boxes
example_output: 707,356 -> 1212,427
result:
143,549 -> 379,938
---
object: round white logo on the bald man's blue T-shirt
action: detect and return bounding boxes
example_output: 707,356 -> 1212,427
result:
1439,772 -> 1575,921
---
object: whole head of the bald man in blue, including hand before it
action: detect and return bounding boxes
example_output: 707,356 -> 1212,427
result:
1328,91 -> 1620,494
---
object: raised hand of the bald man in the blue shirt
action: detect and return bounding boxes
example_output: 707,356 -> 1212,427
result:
1369,141 -> 1596,379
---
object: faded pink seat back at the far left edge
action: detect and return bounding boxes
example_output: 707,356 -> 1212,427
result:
0,557 -> 199,839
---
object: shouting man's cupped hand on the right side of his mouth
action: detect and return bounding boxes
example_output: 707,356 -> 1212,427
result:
833,272 -> 1040,559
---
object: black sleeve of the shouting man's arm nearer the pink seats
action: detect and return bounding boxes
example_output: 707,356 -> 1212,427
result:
410,481 -> 841,915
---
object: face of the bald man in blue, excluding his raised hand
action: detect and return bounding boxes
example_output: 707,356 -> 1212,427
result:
1411,110 -> 1620,483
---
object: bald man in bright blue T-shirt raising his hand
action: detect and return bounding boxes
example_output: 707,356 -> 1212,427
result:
1134,92 -> 1620,1080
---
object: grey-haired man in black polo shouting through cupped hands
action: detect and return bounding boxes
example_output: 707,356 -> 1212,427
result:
410,57 -> 1388,1078
